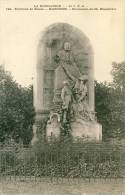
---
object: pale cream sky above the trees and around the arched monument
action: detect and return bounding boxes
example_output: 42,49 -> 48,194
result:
0,0 -> 125,86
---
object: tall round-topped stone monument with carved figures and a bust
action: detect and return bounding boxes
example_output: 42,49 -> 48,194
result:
32,23 -> 102,143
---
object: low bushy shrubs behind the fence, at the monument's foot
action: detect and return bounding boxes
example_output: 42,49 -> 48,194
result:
0,140 -> 125,178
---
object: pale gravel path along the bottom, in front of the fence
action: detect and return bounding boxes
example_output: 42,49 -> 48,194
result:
0,179 -> 125,195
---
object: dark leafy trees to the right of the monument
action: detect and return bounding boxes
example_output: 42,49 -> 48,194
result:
95,62 -> 125,138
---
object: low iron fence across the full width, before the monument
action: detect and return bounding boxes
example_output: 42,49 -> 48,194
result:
0,142 -> 125,181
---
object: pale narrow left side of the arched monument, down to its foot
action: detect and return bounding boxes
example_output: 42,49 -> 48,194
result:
31,44 -> 47,145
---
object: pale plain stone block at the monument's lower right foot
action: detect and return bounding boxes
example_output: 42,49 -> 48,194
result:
71,119 -> 102,141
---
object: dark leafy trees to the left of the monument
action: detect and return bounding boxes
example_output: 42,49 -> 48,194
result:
0,66 -> 34,144
